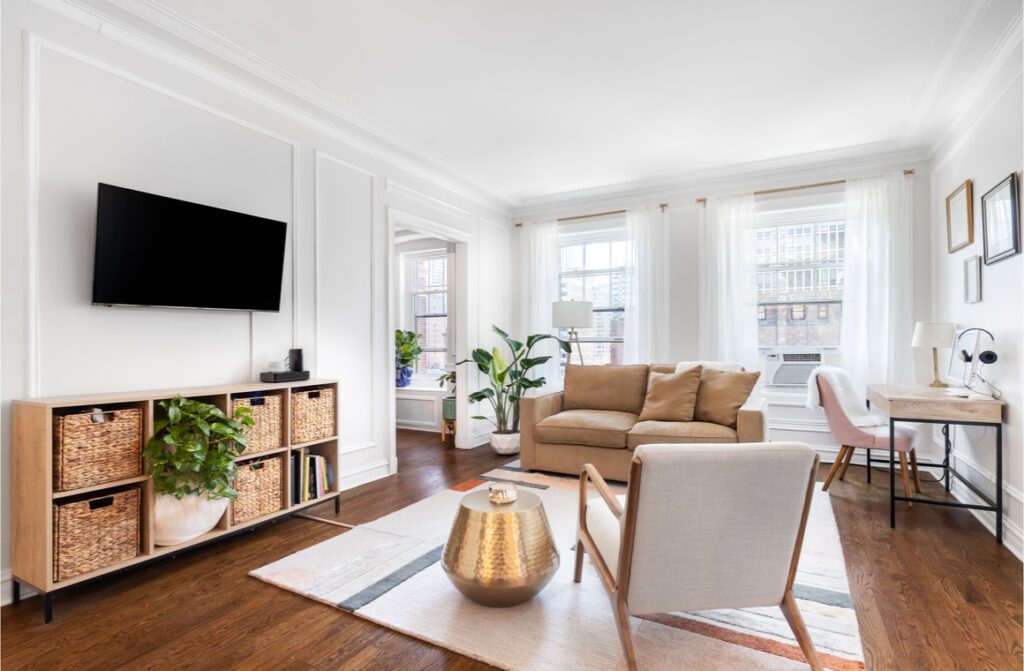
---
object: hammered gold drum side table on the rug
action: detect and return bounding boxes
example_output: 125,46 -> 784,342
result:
441,490 -> 559,607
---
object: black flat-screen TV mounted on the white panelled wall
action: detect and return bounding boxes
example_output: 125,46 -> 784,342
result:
92,184 -> 288,312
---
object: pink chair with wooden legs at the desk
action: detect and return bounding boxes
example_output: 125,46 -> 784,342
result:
817,375 -> 921,506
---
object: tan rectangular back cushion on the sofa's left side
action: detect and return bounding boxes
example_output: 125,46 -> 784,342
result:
562,365 -> 647,415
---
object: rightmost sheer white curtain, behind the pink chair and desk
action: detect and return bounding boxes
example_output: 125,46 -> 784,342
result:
840,172 -> 913,391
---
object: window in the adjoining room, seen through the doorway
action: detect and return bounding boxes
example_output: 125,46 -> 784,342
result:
409,253 -> 449,375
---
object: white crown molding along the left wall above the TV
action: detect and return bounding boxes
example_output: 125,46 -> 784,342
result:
31,0 -> 515,212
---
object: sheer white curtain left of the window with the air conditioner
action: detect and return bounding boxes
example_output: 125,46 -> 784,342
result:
697,194 -> 760,370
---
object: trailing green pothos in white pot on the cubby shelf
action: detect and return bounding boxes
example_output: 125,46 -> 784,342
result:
145,395 -> 253,545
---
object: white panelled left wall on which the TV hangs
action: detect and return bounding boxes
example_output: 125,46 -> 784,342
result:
0,0 -> 512,597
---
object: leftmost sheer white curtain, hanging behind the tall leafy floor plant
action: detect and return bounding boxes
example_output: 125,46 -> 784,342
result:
520,221 -> 562,393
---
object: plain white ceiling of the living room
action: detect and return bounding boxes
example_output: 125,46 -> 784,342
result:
150,0 -> 1021,203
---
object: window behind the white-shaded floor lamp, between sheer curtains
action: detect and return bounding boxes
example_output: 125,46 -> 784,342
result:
558,233 -> 633,366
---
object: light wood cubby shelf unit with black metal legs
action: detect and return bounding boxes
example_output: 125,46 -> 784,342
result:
11,379 -> 340,622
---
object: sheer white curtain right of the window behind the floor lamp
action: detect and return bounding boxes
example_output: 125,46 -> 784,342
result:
623,207 -> 669,364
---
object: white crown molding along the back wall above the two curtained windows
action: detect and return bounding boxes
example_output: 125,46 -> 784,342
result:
512,141 -> 932,218
